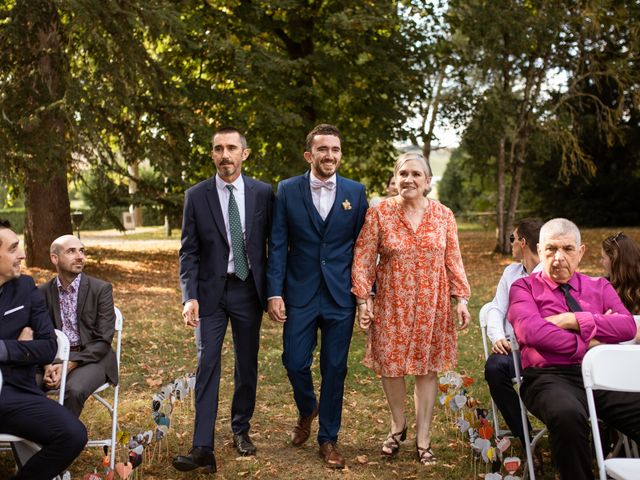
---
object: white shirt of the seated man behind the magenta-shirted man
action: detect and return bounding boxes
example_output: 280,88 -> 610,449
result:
487,263 -> 542,344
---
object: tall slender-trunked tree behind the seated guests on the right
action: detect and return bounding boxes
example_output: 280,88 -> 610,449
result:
449,0 -> 632,253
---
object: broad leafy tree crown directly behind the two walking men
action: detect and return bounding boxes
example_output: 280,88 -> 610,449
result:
174,0 -> 419,183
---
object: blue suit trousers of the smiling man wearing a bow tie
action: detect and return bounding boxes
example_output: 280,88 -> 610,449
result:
282,285 -> 355,445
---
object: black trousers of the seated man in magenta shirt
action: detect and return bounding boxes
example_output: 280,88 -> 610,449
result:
522,365 -> 640,480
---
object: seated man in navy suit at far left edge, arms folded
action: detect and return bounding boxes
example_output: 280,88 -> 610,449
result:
0,220 -> 87,480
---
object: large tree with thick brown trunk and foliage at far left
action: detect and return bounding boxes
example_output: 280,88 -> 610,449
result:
0,0 -> 185,267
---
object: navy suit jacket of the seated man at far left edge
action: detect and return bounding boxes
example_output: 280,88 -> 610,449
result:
0,275 -> 58,395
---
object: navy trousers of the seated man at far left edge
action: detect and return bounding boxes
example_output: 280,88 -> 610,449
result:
0,385 -> 87,480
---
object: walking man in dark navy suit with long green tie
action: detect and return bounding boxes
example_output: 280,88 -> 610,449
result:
173,128 -> 273,472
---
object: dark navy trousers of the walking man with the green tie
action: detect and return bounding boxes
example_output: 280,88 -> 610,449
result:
193,276 -> 263,448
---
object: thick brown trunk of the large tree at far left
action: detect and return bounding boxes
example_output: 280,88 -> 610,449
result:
13,0 -> 73,268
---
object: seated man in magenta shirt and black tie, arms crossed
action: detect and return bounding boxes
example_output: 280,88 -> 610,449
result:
508,218 -> 640,480
